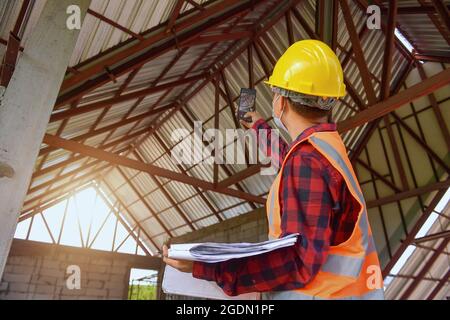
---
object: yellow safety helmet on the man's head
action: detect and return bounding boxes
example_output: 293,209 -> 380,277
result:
264,40 -> 345,98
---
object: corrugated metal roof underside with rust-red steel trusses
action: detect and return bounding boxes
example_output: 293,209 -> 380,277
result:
0,0 -> 450,298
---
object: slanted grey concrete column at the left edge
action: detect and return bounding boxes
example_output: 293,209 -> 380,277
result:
0,0 -> 90,278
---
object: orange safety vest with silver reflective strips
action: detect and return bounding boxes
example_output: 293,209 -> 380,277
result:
263,131 -> 384,300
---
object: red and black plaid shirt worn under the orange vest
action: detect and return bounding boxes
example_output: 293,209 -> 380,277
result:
193,120 -> 359,296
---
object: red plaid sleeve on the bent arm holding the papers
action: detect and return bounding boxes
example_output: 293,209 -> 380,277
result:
193,141 -> 332,296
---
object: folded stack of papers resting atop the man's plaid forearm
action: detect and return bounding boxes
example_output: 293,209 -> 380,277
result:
169,233 -> 299,263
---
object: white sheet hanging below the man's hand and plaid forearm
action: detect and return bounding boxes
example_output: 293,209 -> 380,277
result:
162,266 -> 259,300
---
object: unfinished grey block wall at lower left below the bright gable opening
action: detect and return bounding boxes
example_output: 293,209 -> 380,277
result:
0,240 -> 159,300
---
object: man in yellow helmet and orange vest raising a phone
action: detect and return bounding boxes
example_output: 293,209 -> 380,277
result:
164,40 -> 383,299
